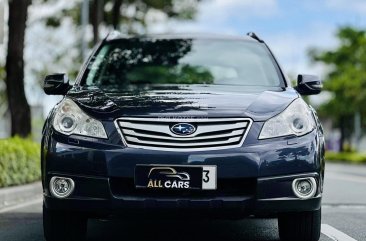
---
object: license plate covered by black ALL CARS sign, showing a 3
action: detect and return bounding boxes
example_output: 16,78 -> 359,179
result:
135,165 -> 217,190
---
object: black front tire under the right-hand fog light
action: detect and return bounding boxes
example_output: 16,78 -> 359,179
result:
278,209 -> 321,241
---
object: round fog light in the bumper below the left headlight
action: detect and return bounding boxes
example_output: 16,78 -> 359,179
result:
50,177 -> 75,198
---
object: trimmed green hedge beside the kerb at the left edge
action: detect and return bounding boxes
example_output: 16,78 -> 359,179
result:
0,137 -> 41,187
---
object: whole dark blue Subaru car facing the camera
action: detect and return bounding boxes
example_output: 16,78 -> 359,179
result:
42,33 -> 324,241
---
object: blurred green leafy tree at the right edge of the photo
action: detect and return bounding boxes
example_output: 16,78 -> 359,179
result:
310,27 -> 366,149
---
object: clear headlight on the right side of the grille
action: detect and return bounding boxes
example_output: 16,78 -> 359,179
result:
259,98 -> 315,139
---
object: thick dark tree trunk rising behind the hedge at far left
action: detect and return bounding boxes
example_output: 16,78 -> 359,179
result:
5,0 -> 31,137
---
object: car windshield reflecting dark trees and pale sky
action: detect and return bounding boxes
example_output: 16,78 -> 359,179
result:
84,38 -> 281,87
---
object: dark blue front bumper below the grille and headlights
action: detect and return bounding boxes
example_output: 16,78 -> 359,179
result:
42,131 -> 323,218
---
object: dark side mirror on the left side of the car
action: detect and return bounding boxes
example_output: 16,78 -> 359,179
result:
43,74 -> 71,95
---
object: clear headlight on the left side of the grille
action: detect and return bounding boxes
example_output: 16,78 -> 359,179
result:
53,98 -> 108,139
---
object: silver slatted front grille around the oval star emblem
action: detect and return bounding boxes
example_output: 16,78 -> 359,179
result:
116,118 -> 252,151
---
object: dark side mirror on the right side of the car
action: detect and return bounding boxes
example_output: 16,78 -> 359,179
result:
295,74 -> 323,95
